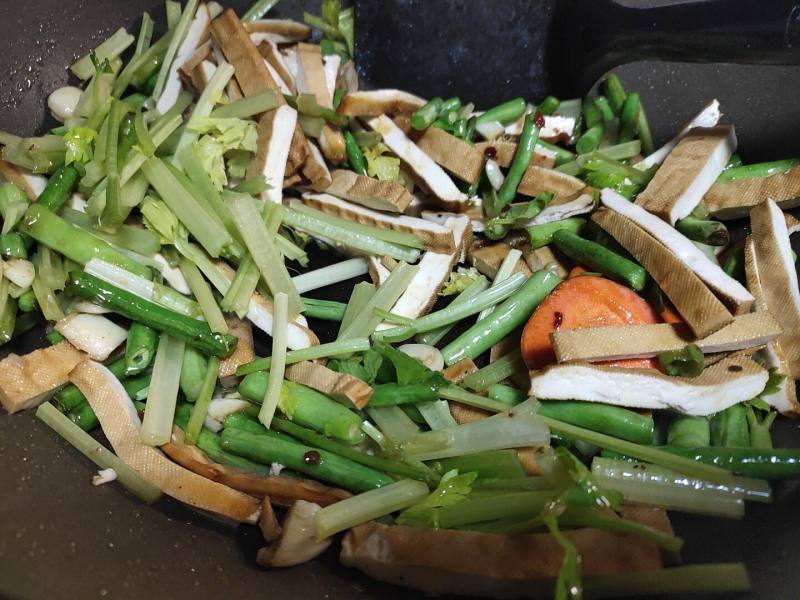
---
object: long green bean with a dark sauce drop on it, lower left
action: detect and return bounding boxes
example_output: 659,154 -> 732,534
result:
220,427 -> 394,492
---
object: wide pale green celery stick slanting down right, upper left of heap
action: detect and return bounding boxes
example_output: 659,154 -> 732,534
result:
142,158 -> 234,258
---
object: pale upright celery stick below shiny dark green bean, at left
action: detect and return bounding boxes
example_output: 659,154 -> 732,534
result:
139,333 -> 186,446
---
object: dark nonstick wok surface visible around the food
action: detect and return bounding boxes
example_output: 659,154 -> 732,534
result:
0,0 -> 800,600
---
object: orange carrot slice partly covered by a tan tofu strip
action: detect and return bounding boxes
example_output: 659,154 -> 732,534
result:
520,274 -> 661,369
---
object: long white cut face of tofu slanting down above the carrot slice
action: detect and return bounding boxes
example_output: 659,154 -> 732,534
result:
600,189 -> 753,315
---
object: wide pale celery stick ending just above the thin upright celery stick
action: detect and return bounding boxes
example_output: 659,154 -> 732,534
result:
226,194 -> 304,319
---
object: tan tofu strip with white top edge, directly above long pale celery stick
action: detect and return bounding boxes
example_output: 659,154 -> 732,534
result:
303,194 -> 456,252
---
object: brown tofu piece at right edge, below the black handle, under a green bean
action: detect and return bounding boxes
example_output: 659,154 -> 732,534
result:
703,165 -> 800,219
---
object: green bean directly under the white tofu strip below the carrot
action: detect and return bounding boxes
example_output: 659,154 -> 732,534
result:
538,400 -> 654,445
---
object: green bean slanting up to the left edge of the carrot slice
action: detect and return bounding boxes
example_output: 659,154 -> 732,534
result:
442,270 -> 561,365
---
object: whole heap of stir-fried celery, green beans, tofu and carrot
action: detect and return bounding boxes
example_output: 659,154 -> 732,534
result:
0,0 -> 800,598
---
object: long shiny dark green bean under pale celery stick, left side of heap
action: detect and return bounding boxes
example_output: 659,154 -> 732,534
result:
68,271 -> 238,357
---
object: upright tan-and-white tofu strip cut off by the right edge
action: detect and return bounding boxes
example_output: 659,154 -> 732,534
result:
750,200 -> 800,379
